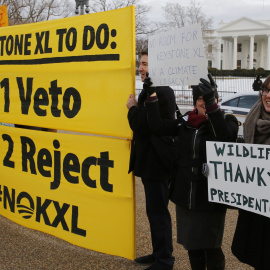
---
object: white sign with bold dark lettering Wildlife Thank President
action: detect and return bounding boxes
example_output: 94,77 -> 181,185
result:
206,142 -> 270,217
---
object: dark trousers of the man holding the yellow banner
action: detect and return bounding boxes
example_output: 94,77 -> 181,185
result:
142,178 -> 174,265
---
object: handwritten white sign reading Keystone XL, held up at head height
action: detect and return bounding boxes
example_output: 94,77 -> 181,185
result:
148,24 -> 207,86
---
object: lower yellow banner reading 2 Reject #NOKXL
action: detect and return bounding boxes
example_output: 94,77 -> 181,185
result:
0,126 -> 135,259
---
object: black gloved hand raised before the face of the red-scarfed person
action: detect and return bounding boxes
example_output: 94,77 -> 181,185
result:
199,74 -> 217,106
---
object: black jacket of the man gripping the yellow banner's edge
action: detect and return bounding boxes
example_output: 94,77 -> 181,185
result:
128,86 -> 175,179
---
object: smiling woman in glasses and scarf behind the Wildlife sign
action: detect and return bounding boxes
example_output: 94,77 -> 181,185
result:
232,76 -> 270,270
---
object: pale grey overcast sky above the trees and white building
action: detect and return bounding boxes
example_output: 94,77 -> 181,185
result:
146,0 -> 270,28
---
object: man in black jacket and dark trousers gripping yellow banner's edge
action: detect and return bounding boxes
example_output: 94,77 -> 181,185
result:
127,52 -> 175,270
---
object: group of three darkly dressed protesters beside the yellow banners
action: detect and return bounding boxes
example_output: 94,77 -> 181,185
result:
127,51 -> 270,270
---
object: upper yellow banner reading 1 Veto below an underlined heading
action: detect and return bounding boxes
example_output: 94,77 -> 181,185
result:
0,6 -> 135,139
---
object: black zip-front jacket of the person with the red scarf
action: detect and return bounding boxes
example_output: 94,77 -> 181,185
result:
147,99 -> 238,210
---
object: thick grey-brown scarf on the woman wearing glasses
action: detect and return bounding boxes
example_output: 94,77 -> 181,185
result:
244,100 -> 270,145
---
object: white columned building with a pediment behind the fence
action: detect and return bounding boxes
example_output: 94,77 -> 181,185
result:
208,17 -> 270,70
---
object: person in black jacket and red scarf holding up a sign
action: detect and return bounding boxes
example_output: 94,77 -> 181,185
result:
145,74 -> 238,270
